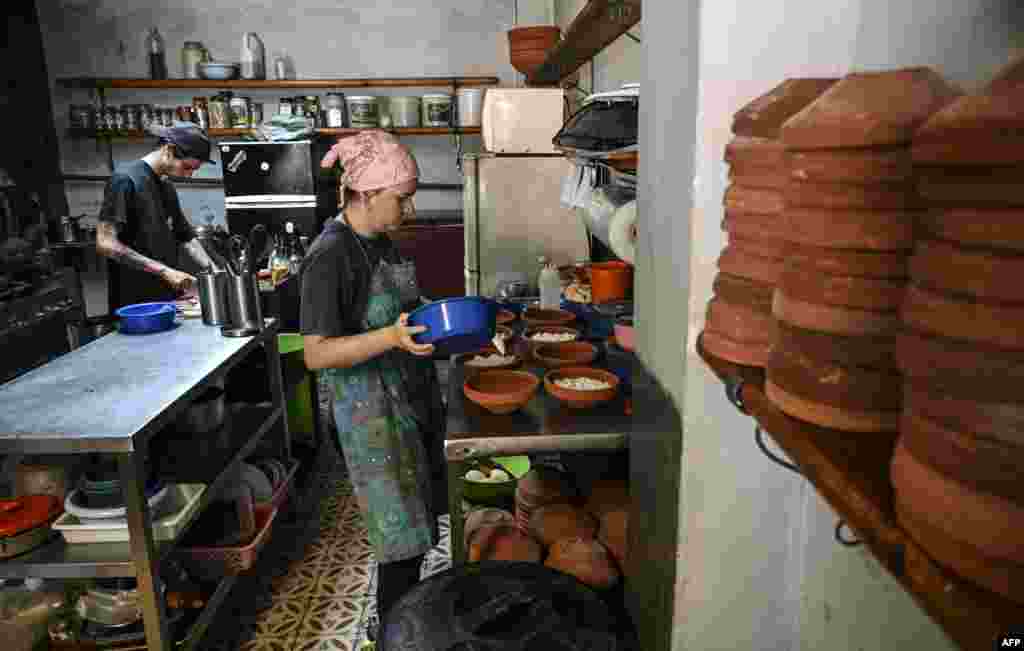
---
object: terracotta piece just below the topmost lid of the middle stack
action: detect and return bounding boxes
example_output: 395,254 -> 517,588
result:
786,146 -> 913,183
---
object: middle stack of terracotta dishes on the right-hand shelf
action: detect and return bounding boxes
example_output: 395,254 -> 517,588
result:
765,69 -> 958,432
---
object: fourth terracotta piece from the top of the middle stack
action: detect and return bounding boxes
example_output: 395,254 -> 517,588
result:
780,207 -> 920,251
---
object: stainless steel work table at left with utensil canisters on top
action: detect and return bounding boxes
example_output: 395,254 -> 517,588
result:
0,319 -> 291,651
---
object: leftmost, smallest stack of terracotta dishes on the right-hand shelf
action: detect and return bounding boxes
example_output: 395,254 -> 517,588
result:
702,79 -> 836,366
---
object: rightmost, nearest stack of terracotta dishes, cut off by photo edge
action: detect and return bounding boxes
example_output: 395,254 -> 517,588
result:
892,83 -> 1024,603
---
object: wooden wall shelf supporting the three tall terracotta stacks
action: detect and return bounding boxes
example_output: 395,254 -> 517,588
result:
697,340 -> 1024,651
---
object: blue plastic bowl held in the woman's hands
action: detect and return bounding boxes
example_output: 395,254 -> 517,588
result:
409,296 -> 499,355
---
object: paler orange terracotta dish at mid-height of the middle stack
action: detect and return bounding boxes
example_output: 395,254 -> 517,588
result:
771,288 -> 900,336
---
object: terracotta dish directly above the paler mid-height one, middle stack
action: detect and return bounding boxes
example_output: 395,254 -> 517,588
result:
776,262 -> 906,312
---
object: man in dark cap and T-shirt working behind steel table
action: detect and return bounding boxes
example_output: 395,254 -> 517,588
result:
96,123 -> 213,313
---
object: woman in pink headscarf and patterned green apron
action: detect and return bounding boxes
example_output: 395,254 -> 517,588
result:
301,131 -> 445,634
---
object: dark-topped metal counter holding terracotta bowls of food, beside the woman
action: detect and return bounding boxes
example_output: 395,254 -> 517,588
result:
444,342 -> 672,563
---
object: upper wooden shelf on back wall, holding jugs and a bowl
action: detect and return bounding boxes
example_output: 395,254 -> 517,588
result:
57,76 -> 501,90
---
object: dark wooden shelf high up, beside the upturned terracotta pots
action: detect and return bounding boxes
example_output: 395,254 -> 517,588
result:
526,0 -> 640,86
